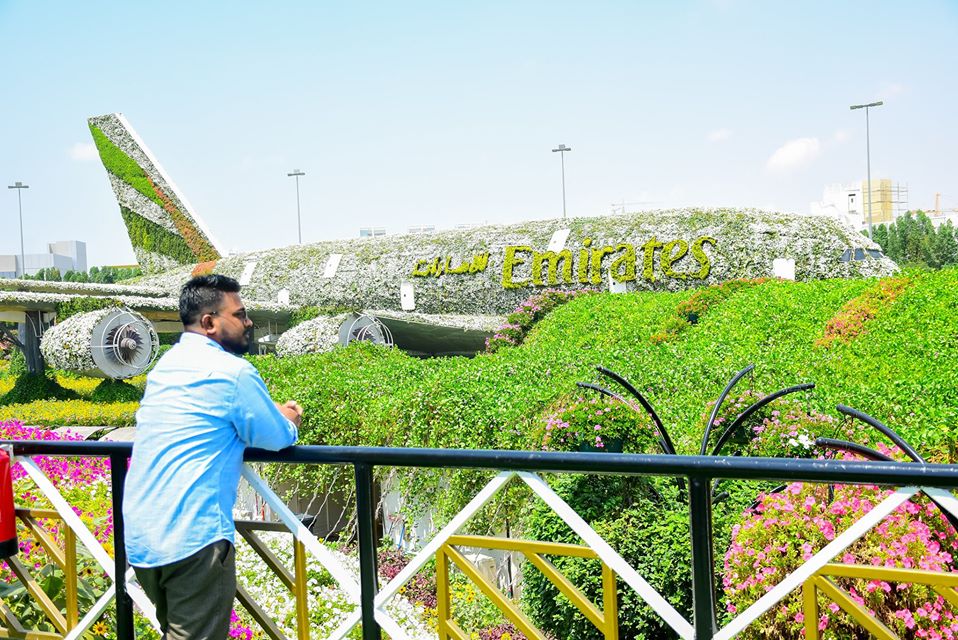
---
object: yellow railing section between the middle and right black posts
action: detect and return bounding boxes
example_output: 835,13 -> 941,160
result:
436,535 -> 619,640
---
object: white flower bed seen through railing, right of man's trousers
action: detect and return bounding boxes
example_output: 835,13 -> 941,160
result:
236,531 -> 436,640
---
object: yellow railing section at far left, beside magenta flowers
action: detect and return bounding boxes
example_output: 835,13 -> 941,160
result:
0,508 -> 79,640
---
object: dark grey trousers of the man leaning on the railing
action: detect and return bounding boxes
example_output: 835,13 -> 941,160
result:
133,540 -> 236,640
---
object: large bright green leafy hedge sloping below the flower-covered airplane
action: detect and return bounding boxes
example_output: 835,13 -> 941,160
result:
254,269 -> 958,492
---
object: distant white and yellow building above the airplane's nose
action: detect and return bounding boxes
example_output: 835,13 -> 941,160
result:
810,178 -> 908,230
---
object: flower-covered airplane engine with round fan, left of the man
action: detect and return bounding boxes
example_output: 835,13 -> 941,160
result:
40,307 -> 159,380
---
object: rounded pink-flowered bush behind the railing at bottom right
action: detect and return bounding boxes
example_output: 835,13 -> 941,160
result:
723,478 -> 958,639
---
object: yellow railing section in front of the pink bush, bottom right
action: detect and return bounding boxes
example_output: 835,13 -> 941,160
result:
802,564 -> 958,640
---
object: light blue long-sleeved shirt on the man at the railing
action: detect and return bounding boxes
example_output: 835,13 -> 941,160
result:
123,333 -> 297,567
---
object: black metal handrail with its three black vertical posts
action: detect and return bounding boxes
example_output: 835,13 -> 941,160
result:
3,441 -> 958,640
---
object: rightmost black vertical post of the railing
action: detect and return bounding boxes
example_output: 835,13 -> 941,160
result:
689,477 -> 716,640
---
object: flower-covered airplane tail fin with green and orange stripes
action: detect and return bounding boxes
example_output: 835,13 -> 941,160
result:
88,113 -> 225,273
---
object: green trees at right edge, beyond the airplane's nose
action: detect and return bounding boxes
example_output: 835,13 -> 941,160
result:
865,210 -> 958,269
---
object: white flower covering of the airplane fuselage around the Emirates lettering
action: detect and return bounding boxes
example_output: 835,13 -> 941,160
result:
135,209 -> 897,314
